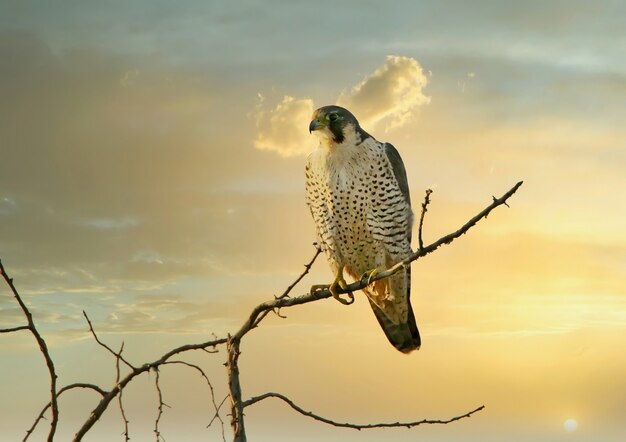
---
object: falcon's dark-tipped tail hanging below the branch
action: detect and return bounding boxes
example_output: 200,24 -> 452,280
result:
366,268 -> 421,353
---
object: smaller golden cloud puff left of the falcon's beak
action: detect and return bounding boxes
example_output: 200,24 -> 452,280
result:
254,94 -> 313,157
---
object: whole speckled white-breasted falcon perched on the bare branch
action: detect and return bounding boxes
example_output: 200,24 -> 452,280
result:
305,105 -> 421,353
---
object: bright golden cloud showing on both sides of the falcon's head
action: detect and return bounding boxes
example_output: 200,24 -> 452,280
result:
254,55 -> 430,157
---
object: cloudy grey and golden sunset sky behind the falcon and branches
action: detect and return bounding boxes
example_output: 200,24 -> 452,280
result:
0,0 -> 626,442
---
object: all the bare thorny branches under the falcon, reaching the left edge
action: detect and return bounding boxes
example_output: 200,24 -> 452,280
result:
0,181 -> 523,442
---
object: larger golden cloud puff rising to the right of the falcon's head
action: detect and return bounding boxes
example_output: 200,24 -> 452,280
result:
337,55 -> 430,130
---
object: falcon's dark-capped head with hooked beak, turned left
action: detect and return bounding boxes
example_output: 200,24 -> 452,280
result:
309,106 -> 362,144
